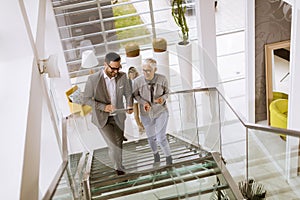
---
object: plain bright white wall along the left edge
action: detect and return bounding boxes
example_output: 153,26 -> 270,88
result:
0,0 -> 33,199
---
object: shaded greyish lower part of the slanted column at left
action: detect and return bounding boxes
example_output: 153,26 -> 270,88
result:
20,64 -> 43,200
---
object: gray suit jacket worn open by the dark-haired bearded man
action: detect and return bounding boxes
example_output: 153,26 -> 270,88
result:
83,69 -> 133,130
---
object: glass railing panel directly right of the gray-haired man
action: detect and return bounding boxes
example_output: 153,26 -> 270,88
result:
169,89 -> 220,152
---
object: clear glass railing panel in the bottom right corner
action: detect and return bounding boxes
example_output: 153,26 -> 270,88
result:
248,129 -> 300,199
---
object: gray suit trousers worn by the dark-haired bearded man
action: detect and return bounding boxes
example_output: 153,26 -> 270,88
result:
98,117 -> 124,171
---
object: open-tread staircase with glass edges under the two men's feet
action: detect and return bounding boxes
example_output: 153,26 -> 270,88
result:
86,135 -> 237,200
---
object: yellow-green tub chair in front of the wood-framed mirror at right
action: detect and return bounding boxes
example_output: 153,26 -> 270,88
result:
270,99 -> 288,140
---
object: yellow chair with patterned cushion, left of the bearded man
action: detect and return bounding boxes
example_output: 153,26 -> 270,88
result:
66,85 -> 92,129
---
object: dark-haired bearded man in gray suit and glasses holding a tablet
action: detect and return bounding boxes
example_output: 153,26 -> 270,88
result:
84,52 -> 133,175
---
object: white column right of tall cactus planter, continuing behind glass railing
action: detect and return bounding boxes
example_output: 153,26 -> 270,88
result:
195,1 -> 220,152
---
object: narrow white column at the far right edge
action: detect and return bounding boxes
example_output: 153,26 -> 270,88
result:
286,1 -> 300,180
